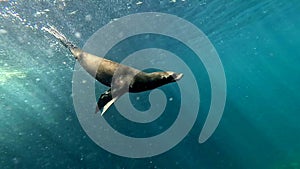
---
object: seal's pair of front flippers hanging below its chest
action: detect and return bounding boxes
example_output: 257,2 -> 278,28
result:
95,89 -> 119,116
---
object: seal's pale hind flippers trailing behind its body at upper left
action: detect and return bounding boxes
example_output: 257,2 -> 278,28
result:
42,25 -> 76,49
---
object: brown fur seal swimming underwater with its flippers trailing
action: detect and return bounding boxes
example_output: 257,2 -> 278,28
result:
42,26 -> 183,115
